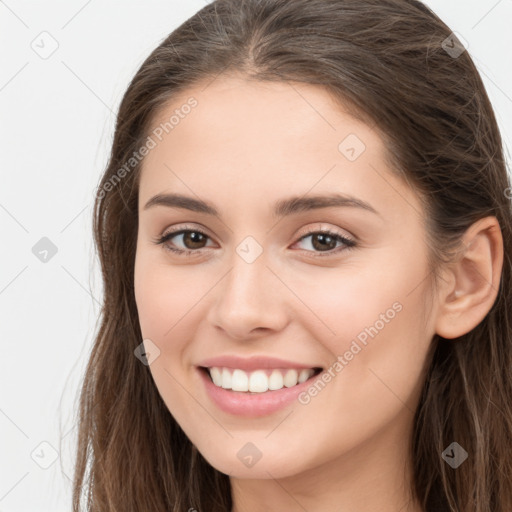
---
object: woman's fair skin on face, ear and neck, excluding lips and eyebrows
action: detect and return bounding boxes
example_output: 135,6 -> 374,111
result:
134,76 -> 502,512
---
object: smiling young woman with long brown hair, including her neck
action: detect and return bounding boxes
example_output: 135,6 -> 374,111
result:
74,0 -> 512,512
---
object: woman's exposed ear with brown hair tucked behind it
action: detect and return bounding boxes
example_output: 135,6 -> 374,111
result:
436,217 -> 503,339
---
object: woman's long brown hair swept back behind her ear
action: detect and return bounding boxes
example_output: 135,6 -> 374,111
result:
73,0 -> 512,512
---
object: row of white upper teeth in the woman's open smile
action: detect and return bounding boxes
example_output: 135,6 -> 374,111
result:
208,367 -> 315,393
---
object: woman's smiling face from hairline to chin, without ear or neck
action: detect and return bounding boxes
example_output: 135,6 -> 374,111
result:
135,77 -> 435,478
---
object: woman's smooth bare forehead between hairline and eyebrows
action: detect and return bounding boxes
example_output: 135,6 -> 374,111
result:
140,77 -> 420,222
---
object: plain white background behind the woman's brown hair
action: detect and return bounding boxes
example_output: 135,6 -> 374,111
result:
0,0 -> 512,512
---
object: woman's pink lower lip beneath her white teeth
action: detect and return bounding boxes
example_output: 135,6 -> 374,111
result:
198,368 -> 318,418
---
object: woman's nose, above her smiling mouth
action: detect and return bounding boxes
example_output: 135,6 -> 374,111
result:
208,251 -> 289,340
